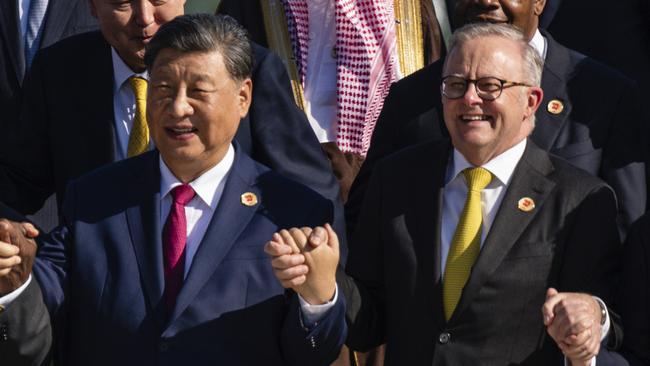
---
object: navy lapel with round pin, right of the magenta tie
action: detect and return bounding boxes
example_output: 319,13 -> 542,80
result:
169,152 -> 264,324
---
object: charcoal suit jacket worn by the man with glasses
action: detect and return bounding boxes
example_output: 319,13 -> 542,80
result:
340,141 -> 620,366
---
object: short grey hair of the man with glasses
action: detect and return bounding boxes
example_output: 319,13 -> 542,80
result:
445,23 -> 544,86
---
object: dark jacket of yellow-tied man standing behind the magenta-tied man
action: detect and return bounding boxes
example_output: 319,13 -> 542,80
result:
0,32 -> 343,239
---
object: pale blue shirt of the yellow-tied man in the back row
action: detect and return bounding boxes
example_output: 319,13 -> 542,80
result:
111,47 -> 153,161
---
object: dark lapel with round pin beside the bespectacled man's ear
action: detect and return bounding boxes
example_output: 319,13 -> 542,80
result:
531,31 -> 573,151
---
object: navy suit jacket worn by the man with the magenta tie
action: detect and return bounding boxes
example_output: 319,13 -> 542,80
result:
19,146 -> 346,366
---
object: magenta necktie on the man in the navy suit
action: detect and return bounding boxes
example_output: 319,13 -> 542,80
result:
163,184 -> 196,314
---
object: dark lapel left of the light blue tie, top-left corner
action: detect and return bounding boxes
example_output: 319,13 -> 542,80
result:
0,0 -> 25,85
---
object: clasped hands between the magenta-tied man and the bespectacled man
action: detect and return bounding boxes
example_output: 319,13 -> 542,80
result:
264,224 -> 339,305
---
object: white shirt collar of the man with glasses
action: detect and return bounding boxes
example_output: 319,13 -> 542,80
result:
446,139 -> 526,186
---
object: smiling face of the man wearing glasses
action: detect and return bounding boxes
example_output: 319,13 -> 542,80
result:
442,36 -> 542,166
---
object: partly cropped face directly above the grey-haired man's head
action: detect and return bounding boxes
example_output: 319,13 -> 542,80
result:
452,0 -> 546,40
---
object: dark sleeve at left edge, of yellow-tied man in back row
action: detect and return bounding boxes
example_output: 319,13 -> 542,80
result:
0,50 -> 54,214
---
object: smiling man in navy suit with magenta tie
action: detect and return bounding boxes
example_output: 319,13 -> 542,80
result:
0,14 -> 345,365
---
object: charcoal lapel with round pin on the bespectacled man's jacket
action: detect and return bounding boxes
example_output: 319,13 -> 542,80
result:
450,141 -> 555,322
